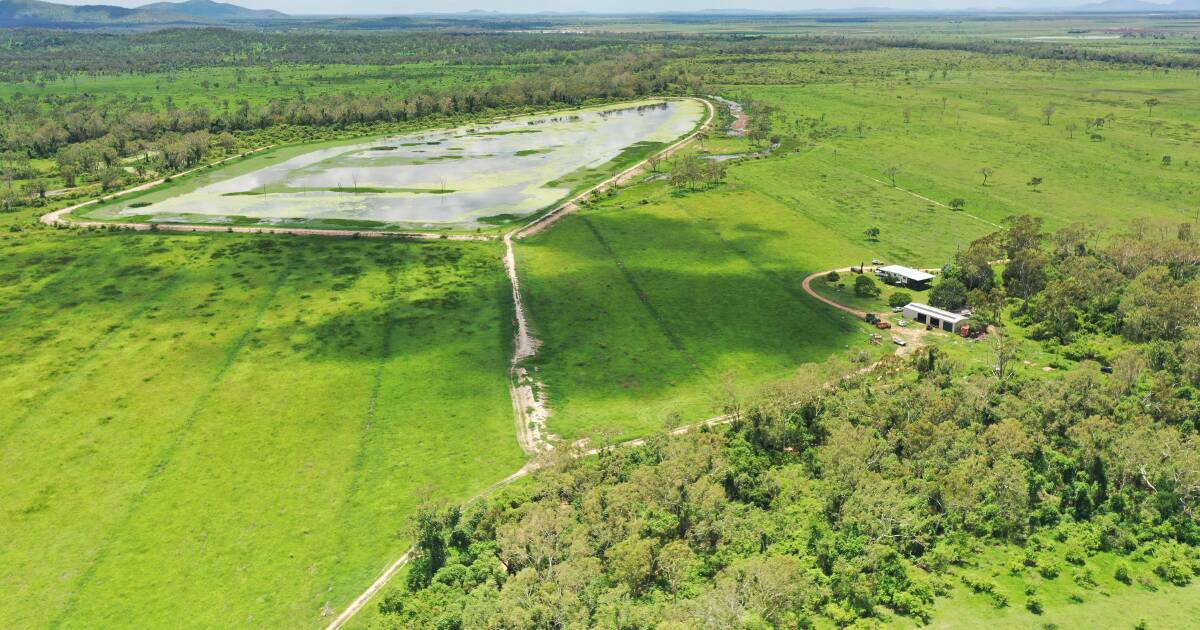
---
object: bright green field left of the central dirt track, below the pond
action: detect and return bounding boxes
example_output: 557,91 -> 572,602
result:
0,220 -> 523,628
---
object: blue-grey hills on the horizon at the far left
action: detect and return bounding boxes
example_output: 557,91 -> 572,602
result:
0,0 -> 288,28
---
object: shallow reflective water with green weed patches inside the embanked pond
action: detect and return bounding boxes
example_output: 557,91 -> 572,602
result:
120,101 -> 703,226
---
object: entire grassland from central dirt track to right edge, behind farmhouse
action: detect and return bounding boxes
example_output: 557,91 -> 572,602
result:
517,58 -> 1200,438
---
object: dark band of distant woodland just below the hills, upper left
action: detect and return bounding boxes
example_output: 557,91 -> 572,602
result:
0,29 -> 684,83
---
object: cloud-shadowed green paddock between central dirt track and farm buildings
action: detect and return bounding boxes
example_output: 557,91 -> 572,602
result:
517,174 -> 883,438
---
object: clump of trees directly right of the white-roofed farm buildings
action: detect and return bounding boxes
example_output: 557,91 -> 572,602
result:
930,216 -> 1200,360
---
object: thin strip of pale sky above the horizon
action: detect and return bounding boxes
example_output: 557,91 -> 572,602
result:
50,0 -> 1142,14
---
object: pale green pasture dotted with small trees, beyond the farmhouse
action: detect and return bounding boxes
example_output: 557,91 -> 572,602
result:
731,65 -> 1200,231
